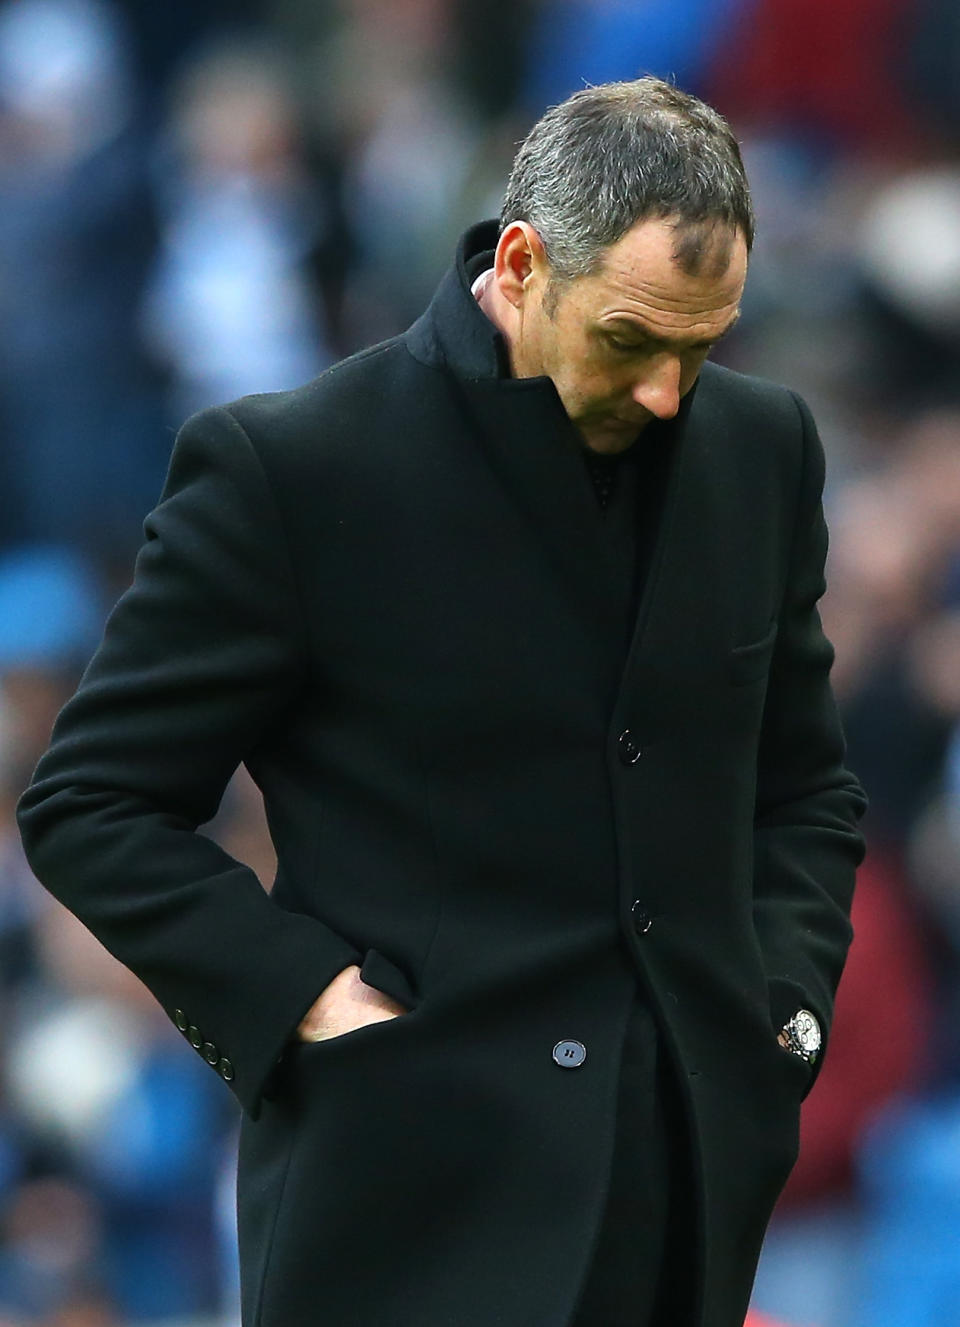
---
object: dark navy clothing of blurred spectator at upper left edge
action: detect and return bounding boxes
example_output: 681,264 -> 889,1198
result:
0,122 -> 173,557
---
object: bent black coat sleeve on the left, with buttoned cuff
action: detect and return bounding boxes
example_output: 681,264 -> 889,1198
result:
17,409 -> 360,1117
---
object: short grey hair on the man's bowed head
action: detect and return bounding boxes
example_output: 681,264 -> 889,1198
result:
501,77 -> 754,280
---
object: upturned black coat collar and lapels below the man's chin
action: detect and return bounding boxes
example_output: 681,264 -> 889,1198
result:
406,222 -> 696,716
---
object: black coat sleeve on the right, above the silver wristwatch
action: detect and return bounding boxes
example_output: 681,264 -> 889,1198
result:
754,397 -> 866,1085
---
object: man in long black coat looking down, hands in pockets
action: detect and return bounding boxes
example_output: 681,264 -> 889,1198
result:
20,78 -> 863,1327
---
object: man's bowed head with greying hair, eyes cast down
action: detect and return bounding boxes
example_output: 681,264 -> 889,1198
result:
483,78 -> 754,451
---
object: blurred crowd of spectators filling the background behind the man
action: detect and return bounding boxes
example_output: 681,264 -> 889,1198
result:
0,0 -> 960,1327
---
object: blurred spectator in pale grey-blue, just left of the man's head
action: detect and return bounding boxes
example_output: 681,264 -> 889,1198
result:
307,0 -> 488,346
